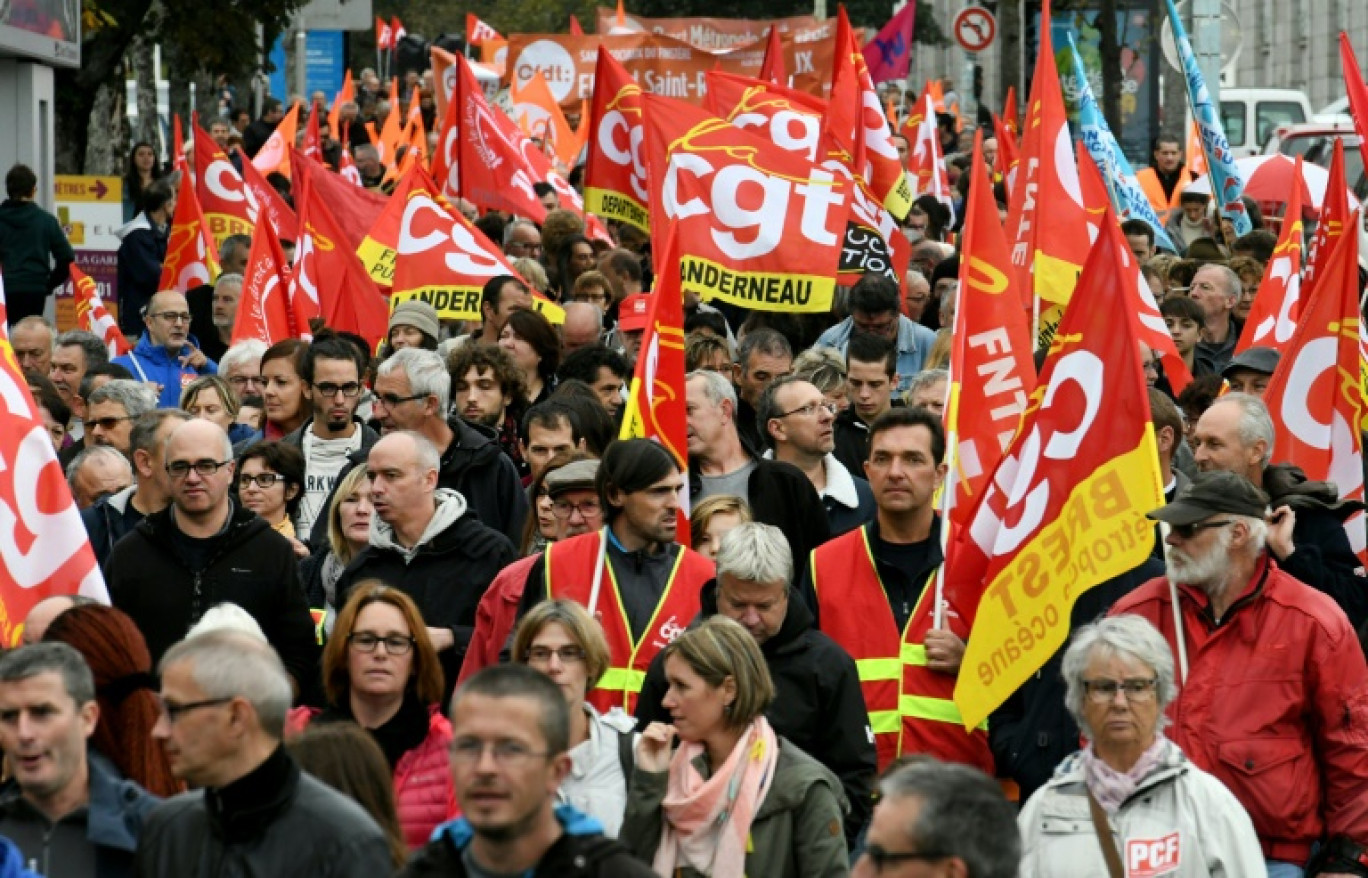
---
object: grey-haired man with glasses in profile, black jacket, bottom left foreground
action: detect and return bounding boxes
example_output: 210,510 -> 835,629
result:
145,630 -> 393,878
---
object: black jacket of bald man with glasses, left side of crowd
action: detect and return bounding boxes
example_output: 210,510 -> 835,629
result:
105,503 -> 319,689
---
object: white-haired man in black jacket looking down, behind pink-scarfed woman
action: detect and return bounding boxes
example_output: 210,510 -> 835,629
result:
636,522 -> 870,845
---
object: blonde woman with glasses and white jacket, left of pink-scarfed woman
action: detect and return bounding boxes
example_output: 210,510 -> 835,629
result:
513,600 -> 636,838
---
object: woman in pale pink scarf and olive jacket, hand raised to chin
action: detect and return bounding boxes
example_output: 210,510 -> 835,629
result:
621,615 -> 850,878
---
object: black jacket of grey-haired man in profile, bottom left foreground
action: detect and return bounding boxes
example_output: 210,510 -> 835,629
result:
134,748 -> 393,878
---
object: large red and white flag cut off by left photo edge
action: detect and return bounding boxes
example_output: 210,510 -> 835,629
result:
0,343 -> 109,648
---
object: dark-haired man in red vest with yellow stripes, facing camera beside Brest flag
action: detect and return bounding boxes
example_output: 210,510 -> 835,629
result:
803,406 -> 993,774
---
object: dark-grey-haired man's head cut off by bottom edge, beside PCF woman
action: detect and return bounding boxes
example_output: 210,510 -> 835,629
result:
851,759 -> 1022,878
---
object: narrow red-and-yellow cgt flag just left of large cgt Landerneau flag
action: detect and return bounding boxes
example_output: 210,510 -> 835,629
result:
584,52 -> 651,234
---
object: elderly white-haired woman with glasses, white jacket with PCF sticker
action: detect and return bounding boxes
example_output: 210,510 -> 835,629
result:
1018,615 -> 1265,878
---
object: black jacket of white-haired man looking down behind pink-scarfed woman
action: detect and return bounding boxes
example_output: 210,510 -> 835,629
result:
636,580 -> 878,845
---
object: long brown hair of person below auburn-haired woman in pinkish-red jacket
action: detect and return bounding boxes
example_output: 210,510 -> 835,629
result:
285,722 -> 409,868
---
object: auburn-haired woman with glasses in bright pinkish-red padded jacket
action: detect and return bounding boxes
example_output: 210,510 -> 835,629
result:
287,580 -> 458,848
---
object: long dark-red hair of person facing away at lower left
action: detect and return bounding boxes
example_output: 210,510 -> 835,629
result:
42,603 -> 183,797
